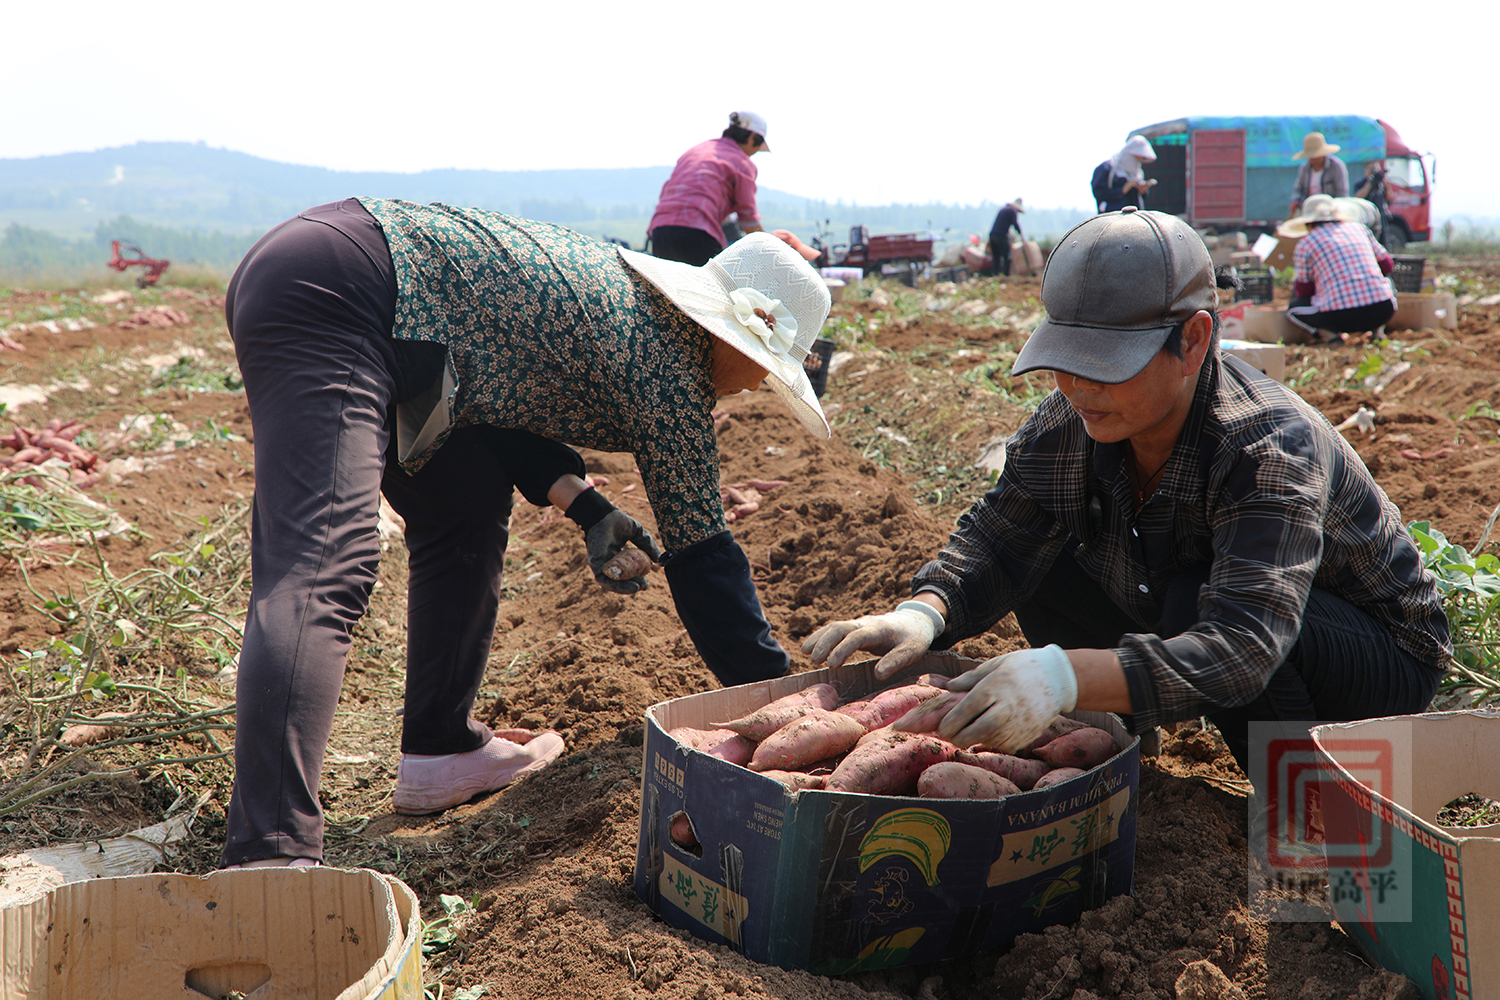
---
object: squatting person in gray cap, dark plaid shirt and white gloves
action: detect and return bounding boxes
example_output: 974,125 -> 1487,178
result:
803,208 -> 1452,768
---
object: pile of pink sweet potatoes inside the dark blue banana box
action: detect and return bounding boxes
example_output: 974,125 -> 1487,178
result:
668,673 -> 1119,799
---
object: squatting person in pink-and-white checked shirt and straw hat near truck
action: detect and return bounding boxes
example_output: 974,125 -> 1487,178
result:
1277,195 -> 1397,342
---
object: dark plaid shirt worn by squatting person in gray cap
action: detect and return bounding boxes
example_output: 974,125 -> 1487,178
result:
912,352 -> 1452,729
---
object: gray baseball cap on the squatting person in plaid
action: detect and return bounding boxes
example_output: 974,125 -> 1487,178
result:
1011,205 -> 1218,384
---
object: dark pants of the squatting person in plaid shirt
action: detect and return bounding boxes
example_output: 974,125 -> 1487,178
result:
1016,550 -> 1442,774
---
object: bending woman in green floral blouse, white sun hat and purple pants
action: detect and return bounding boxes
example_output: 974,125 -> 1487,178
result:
224,198 -> 830,865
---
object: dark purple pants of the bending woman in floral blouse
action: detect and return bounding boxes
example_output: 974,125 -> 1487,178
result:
222,199 -> 512,865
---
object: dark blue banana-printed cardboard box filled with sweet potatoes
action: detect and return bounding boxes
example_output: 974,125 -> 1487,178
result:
635,652 -> 1143,975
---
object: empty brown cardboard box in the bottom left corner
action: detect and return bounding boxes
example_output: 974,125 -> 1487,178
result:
0,867 -> 422,1000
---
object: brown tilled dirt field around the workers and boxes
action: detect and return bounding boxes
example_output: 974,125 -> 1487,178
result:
0,262 -> 1500,1000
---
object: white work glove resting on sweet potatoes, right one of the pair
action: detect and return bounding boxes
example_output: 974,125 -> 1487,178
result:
938,646 -> 1079,753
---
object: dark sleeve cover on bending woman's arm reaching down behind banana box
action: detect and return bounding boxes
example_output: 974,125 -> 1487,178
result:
663,531 -> 792,688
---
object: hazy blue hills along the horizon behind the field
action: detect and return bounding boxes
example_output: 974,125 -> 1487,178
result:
0,142 -> 1083,280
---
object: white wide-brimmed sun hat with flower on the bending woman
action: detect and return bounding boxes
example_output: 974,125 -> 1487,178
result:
620,232 -> 833,439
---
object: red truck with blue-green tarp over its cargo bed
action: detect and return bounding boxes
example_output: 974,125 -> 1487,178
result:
1131,115 -> 1433,250
